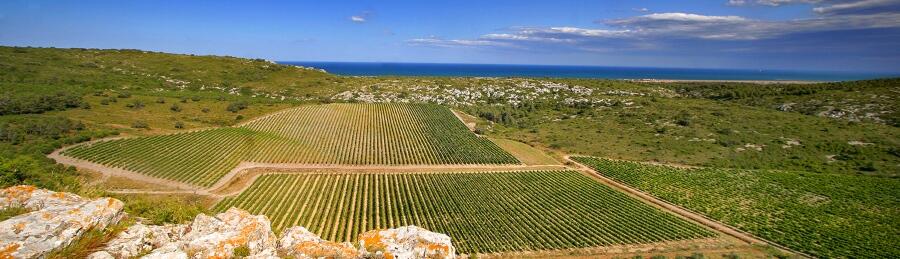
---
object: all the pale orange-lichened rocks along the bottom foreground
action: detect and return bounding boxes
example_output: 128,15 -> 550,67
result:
0,186 -> 456,259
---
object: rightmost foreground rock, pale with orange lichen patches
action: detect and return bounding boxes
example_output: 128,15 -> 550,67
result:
359,226 -> 456,259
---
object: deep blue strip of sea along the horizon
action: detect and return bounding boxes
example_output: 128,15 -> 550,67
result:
278,61 -> 900,81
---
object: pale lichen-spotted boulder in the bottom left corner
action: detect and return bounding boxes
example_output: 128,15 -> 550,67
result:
0,185 -> 124,258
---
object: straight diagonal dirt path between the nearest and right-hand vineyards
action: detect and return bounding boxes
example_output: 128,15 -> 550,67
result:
564,155 -> 812,258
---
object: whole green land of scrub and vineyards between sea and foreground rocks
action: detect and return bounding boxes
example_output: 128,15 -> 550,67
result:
0,47 -> 900,257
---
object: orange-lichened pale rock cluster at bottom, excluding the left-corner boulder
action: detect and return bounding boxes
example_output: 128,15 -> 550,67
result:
91,211 -> 456,259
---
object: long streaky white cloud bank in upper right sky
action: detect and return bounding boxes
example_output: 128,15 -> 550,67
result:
409,0 -> 900,51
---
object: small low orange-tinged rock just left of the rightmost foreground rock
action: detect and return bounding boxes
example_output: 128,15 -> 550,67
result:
278,227 -> 360,258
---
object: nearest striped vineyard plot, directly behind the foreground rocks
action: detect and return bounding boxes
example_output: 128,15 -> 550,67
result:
214,171 -> 716,253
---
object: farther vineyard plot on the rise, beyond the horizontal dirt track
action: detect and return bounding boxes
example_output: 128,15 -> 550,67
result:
62,104 -> 519,187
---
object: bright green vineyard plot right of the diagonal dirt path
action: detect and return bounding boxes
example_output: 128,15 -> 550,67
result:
573,157 -> 900,258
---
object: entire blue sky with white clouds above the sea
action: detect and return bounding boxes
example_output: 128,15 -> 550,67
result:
0,0 -> 900,73
